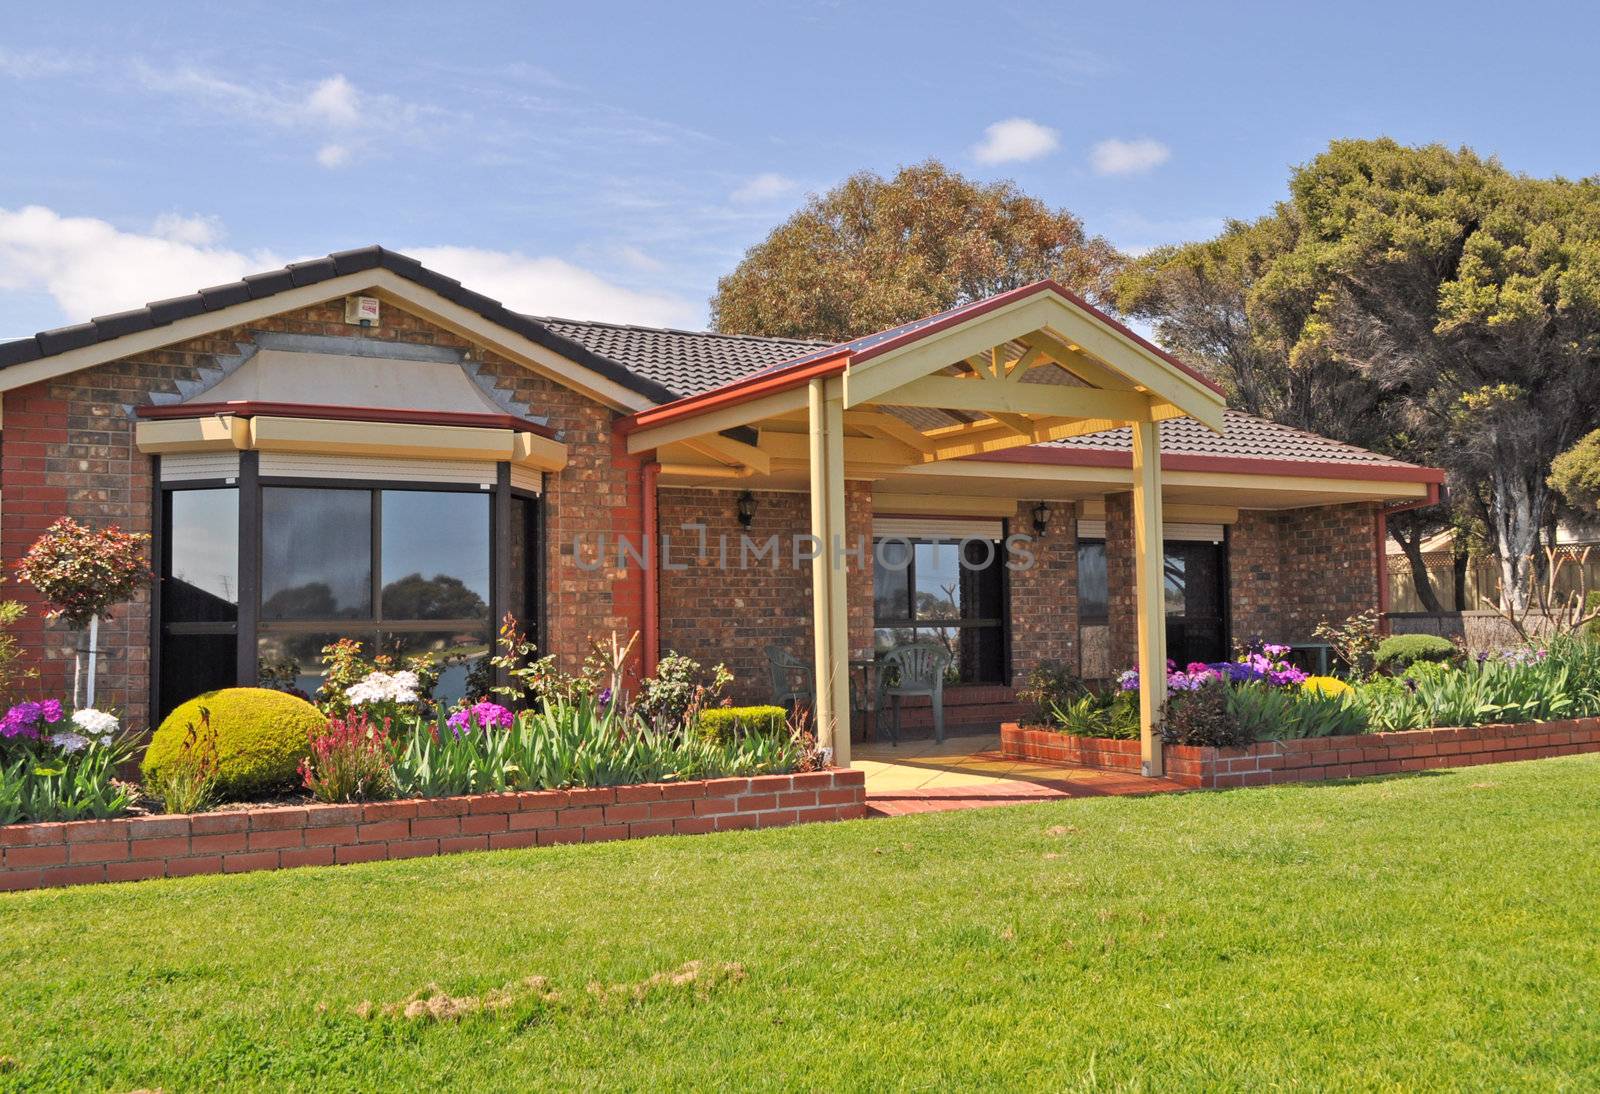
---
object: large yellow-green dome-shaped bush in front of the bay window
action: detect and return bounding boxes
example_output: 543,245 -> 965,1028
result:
141,688 -> 326,798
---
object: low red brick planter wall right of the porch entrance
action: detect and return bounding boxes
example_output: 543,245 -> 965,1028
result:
1000,718 -> 1600,787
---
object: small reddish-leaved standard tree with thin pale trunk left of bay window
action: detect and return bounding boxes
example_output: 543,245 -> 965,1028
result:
16,517 -> 150,707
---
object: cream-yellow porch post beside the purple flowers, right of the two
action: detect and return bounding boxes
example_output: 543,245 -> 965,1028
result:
1133,422 -> 1166,776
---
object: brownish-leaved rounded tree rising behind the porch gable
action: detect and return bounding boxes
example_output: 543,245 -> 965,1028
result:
710,160 -> 1122,342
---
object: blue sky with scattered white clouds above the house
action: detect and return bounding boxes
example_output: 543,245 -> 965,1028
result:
0,0 -> 1600,337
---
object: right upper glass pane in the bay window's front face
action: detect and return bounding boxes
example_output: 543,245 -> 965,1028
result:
379,489 -> 490,619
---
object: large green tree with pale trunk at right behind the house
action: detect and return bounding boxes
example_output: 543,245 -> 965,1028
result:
1118,139 -> 1600,609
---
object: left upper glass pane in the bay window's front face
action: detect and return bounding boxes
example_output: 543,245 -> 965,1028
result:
261,486 -> 373,619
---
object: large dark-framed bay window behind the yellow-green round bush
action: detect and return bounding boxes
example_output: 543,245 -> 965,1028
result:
157,480 -> 539,715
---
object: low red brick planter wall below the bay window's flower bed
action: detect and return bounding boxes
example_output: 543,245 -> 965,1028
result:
0,771 -> 866,889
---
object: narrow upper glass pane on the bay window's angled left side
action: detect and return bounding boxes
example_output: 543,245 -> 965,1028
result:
162,488 -> 238,622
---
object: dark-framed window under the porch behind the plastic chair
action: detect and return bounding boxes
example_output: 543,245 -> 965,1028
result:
872,536 -> 1005,683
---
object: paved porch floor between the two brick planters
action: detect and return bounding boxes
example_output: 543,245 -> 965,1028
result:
851,733 -> 1184,817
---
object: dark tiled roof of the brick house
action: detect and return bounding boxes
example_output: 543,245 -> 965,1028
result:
0,246 -> 1430,472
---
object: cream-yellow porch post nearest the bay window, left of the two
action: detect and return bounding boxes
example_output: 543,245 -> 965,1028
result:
808,379 -> 850,768
